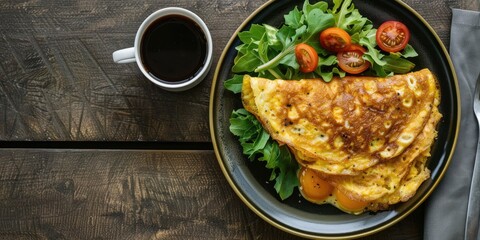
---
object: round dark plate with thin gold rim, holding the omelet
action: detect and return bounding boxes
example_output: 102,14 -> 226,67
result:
210,0 -> 460,239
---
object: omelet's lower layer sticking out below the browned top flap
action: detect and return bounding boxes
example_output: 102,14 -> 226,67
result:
323,105 -> 441,202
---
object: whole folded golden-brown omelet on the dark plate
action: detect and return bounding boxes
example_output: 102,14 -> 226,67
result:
242,69 -> 442,213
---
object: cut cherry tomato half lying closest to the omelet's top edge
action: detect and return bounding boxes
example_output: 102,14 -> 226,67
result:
337,44 -> 370,74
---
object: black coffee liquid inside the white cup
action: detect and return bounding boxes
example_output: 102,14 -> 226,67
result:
140,15 -> 207,82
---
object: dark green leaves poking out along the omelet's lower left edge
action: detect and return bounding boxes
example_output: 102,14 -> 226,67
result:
230,108 -> 299,200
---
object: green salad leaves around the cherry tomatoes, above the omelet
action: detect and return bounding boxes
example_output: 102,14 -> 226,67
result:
232,0 -> 417,82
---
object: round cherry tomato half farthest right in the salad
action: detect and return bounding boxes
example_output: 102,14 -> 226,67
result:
376,21 -> 410,52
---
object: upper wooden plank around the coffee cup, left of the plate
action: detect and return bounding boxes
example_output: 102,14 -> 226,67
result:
0,0 -> 263,142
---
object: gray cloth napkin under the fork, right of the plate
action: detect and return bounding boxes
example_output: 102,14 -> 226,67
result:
424,9 -> 480,240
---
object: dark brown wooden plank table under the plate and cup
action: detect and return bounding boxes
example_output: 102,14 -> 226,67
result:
0,0 -> 479,239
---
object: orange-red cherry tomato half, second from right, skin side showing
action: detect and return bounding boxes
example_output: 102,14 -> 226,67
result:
320,27 -> 352,52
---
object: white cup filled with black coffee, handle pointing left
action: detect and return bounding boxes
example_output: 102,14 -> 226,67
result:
113,7 -> 213,91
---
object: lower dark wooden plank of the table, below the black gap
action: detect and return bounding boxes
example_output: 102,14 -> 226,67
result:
0,149 -> 422,239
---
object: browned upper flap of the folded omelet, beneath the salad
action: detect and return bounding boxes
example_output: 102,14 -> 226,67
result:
242,69 -> 437,175
